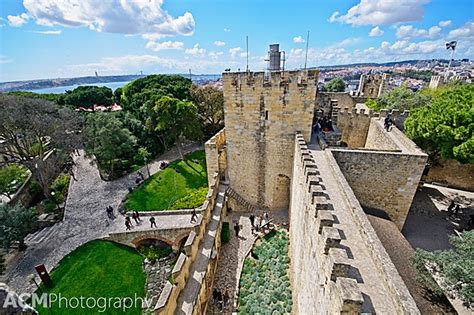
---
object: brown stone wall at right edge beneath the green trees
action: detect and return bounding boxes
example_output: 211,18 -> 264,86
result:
425,160 -> 474,191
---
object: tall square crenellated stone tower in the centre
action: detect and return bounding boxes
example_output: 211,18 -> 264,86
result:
223,70 -> 319,210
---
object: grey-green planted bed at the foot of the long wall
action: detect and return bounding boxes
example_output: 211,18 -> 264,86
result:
238,230 -> 292,314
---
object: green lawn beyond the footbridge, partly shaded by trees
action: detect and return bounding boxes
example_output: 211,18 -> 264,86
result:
125,151 -> 208,211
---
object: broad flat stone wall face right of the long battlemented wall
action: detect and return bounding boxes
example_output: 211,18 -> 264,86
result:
331,149 -> 427,230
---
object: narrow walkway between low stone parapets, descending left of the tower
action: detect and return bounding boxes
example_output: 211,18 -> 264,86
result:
175,184 -> 227,315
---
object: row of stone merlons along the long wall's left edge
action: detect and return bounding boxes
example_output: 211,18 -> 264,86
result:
294,133 -> 364,314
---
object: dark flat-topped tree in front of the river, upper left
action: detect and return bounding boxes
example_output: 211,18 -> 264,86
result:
64,85 -> 113,108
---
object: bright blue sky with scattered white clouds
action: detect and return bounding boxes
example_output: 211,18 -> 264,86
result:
0,0 -> 474,82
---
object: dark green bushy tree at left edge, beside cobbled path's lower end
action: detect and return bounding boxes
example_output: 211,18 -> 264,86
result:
0,203 -> 37,250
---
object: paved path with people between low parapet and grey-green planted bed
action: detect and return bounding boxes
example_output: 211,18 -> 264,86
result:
207,210 -> 288,314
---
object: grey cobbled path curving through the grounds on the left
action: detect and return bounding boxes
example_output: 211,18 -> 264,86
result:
6,144 -> 203,293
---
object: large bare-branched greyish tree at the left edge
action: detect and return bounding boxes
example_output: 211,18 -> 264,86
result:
0,95 -> 81,199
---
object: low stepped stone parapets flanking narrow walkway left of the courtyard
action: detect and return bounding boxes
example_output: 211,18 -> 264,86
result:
155,173 -> 222,314
